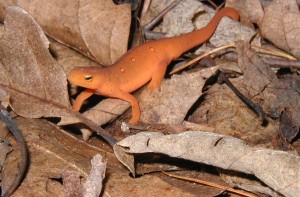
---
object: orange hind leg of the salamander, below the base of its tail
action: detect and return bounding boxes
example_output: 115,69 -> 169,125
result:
148,63 -> 168,92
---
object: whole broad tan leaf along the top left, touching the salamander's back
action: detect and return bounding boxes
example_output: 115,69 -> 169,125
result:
0,0 -> 131,65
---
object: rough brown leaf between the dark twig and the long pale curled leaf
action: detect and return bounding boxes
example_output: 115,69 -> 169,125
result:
186,79 -> 278,147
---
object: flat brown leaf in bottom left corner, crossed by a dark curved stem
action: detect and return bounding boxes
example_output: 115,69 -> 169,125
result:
2,118 -> 95,196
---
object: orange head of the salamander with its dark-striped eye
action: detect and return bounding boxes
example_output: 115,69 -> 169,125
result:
68,67 -> 104,89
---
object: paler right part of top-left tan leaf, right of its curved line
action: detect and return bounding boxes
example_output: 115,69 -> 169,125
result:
78,0 -> 131,65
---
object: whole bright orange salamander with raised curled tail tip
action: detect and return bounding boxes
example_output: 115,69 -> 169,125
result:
68,8 -> 239,124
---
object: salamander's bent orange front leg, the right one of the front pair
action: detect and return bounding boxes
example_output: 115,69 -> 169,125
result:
111,91 -> 141,124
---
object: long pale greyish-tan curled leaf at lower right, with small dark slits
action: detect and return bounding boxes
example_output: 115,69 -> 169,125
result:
117,131 -> 300,196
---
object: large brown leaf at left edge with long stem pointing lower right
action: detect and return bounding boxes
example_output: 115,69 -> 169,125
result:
0,6 -> 114,144
